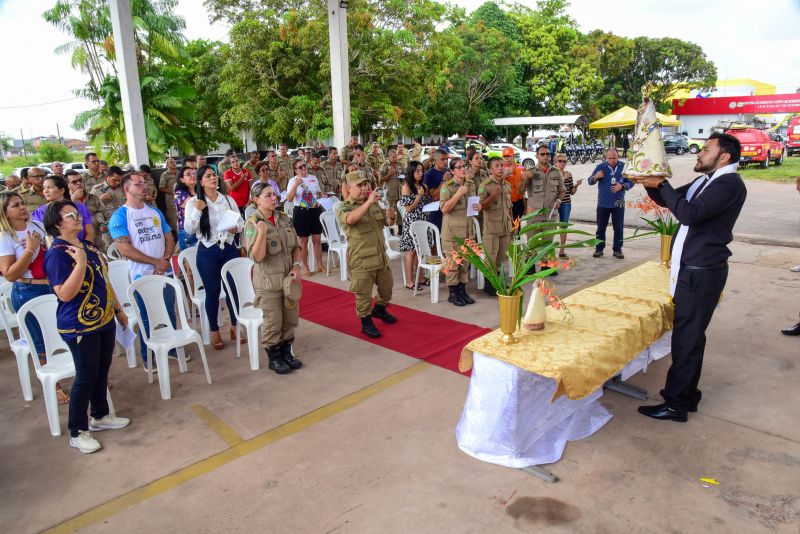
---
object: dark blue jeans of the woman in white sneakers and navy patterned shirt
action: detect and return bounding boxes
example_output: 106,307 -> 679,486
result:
64,323 -> 116,438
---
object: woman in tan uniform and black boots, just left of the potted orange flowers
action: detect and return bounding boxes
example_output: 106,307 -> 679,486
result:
439,158 -> 481,306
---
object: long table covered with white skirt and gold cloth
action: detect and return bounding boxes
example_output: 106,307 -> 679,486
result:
456,262 -> 674,468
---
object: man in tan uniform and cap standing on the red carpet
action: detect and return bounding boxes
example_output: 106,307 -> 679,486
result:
336,171 -> 397,338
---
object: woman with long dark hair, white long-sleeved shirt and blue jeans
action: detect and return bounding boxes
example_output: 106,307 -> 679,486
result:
183,165 -> 245,350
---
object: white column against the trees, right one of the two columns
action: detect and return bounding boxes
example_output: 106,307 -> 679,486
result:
328,0 -> 352,150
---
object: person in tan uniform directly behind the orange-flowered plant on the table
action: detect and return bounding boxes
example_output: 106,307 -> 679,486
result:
478,157 -> 513,296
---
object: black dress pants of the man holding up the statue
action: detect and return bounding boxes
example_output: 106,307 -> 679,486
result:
661,266 -> 728,410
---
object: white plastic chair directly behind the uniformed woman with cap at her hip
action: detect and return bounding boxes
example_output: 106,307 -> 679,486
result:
222,258 -> 264,371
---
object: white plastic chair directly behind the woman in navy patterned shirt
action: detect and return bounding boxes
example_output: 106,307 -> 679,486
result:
18,295 -> 114,436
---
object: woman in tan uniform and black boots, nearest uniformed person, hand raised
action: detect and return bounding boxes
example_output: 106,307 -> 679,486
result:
244,182 -> 303,375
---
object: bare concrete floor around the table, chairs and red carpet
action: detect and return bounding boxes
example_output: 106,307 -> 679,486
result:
0,224 -> 800,534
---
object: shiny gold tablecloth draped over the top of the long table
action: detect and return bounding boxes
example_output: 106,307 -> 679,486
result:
459,262 -> 674,400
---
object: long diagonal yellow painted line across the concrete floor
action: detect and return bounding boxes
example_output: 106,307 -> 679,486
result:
43,362 -> 430,533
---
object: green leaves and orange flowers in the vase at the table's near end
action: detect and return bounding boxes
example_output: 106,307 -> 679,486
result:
444,209 -> 598,296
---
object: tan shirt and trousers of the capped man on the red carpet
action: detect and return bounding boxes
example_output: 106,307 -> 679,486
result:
336,198 -> 394,317
